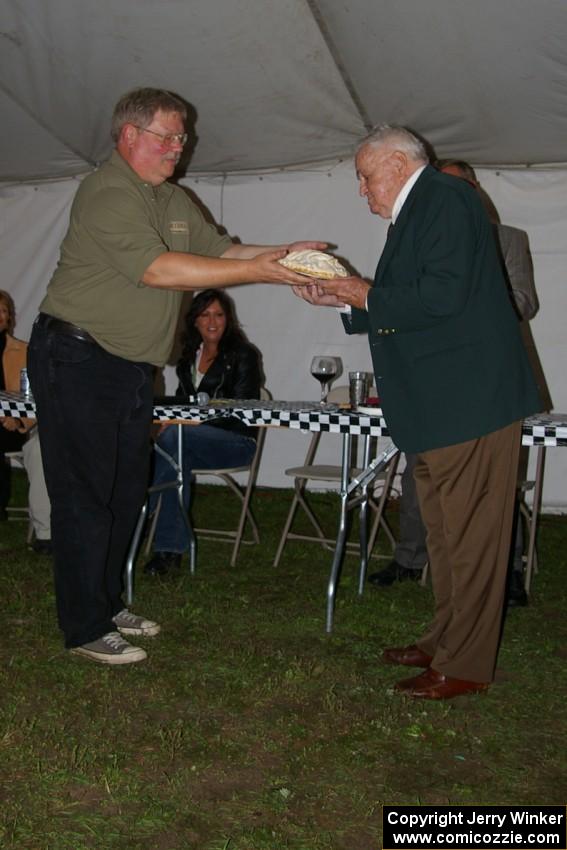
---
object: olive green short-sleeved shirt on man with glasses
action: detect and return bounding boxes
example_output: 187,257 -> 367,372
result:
40,151 -> 232,366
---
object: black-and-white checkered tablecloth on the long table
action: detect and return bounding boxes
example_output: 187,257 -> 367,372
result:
0,392 -> 567,446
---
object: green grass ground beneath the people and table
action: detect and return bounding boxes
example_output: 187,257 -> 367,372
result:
0,474 -> 567,850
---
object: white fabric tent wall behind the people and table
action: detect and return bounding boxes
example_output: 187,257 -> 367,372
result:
0,161 -> 567,510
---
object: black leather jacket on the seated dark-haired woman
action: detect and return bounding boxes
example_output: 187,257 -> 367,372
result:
176,343 -> 262,440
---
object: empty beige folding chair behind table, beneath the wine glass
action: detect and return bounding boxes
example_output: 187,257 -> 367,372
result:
274,386 -> 399,567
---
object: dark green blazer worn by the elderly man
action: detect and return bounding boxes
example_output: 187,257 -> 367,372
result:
343,166 -> 542,452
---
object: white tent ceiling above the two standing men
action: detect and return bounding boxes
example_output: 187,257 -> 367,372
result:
0,0 -> 567,182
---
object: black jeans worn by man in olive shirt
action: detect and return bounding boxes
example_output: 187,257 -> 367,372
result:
28,324 -> 153,647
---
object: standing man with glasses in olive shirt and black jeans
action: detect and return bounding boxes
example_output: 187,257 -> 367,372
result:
28,88 -> 325,664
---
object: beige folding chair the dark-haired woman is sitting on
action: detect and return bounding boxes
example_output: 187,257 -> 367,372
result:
145,388 -> 271,567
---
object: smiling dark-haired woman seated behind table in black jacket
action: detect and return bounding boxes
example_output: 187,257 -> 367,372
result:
144,289 -> 262,575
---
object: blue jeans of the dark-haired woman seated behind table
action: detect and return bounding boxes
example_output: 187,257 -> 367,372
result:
150,425 -> 256,553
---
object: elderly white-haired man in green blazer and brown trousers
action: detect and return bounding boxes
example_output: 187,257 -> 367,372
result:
295,125 -> 541,699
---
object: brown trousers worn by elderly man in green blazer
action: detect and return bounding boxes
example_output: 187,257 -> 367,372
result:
414,422 -> 521,682
